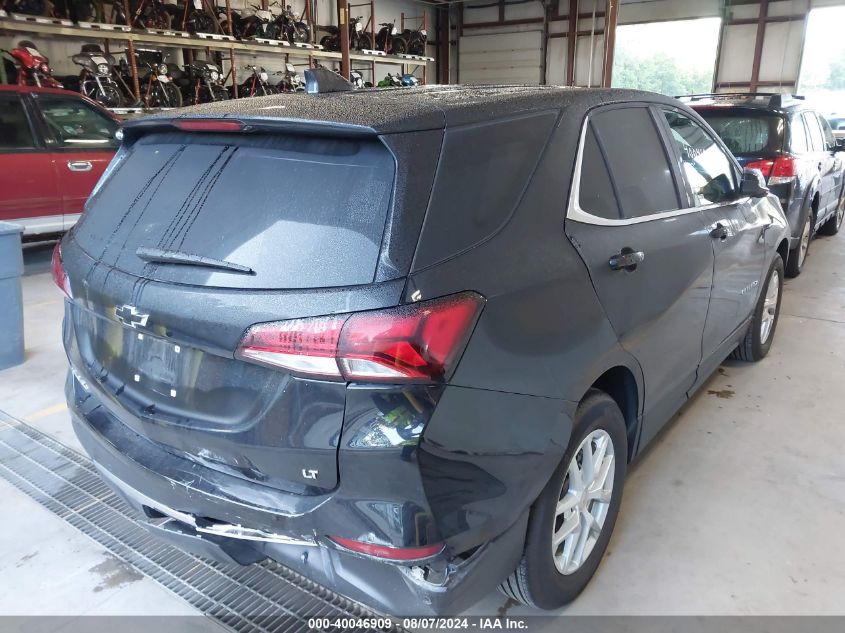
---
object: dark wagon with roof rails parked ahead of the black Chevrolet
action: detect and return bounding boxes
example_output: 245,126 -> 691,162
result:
682,93 -> 845,277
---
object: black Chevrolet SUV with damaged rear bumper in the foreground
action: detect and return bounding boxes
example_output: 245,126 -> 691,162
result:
53,84 -> 789,614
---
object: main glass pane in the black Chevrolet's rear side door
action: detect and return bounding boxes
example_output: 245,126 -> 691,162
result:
590,107 -> 680,218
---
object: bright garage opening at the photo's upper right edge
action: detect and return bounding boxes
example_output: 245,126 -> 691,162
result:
798,7 -> 845,117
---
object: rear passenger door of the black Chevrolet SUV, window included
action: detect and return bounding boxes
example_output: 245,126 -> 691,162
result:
566,107 -> 713,447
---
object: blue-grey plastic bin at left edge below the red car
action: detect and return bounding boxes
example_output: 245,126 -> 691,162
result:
0,222 -> 23,369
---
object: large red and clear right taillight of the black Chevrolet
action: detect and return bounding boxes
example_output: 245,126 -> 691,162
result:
235,292 -> 484,382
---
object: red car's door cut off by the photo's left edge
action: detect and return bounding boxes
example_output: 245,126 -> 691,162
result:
0,94 -> 62,233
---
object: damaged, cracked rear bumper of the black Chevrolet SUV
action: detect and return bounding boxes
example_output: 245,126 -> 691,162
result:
66,374 -> 570,616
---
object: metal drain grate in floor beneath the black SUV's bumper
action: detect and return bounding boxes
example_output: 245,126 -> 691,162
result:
0,411 -> 396,633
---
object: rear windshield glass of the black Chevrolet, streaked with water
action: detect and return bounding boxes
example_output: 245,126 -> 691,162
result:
75,134 -> 394,289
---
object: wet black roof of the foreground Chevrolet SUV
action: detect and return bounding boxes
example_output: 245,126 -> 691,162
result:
134,85 -> 678,134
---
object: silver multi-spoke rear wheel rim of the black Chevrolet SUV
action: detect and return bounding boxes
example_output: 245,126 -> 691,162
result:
552,429 -> 615,575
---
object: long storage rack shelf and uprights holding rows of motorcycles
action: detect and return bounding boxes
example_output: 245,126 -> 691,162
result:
0,0 -> 434,103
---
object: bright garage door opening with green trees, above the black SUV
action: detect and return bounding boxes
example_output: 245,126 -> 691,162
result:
612,18 -> 722,95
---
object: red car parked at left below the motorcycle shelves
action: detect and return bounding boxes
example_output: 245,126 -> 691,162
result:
0,85 -> 119,240
